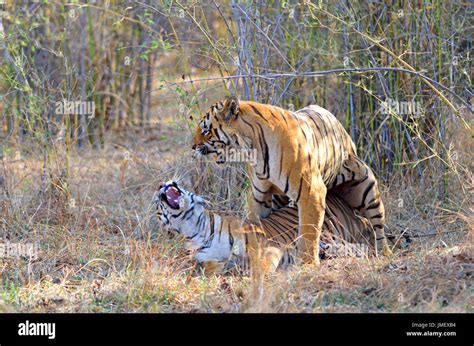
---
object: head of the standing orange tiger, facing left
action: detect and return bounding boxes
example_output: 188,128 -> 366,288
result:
192,96 -> 240,164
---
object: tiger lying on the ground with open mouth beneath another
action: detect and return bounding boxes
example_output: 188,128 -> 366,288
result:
155,181 -> 374,273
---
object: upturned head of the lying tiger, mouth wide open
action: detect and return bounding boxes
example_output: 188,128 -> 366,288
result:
155,180 -> 204,235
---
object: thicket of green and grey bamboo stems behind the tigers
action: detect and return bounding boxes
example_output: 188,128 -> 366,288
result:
0,0 -> 472,195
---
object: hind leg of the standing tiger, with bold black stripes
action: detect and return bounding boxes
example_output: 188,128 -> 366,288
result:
331,155 -> 392,256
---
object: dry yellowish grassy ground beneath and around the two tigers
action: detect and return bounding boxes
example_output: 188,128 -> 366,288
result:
0,125 -> 474,312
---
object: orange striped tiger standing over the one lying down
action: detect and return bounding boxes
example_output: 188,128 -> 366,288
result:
193,97 -> 391,264
